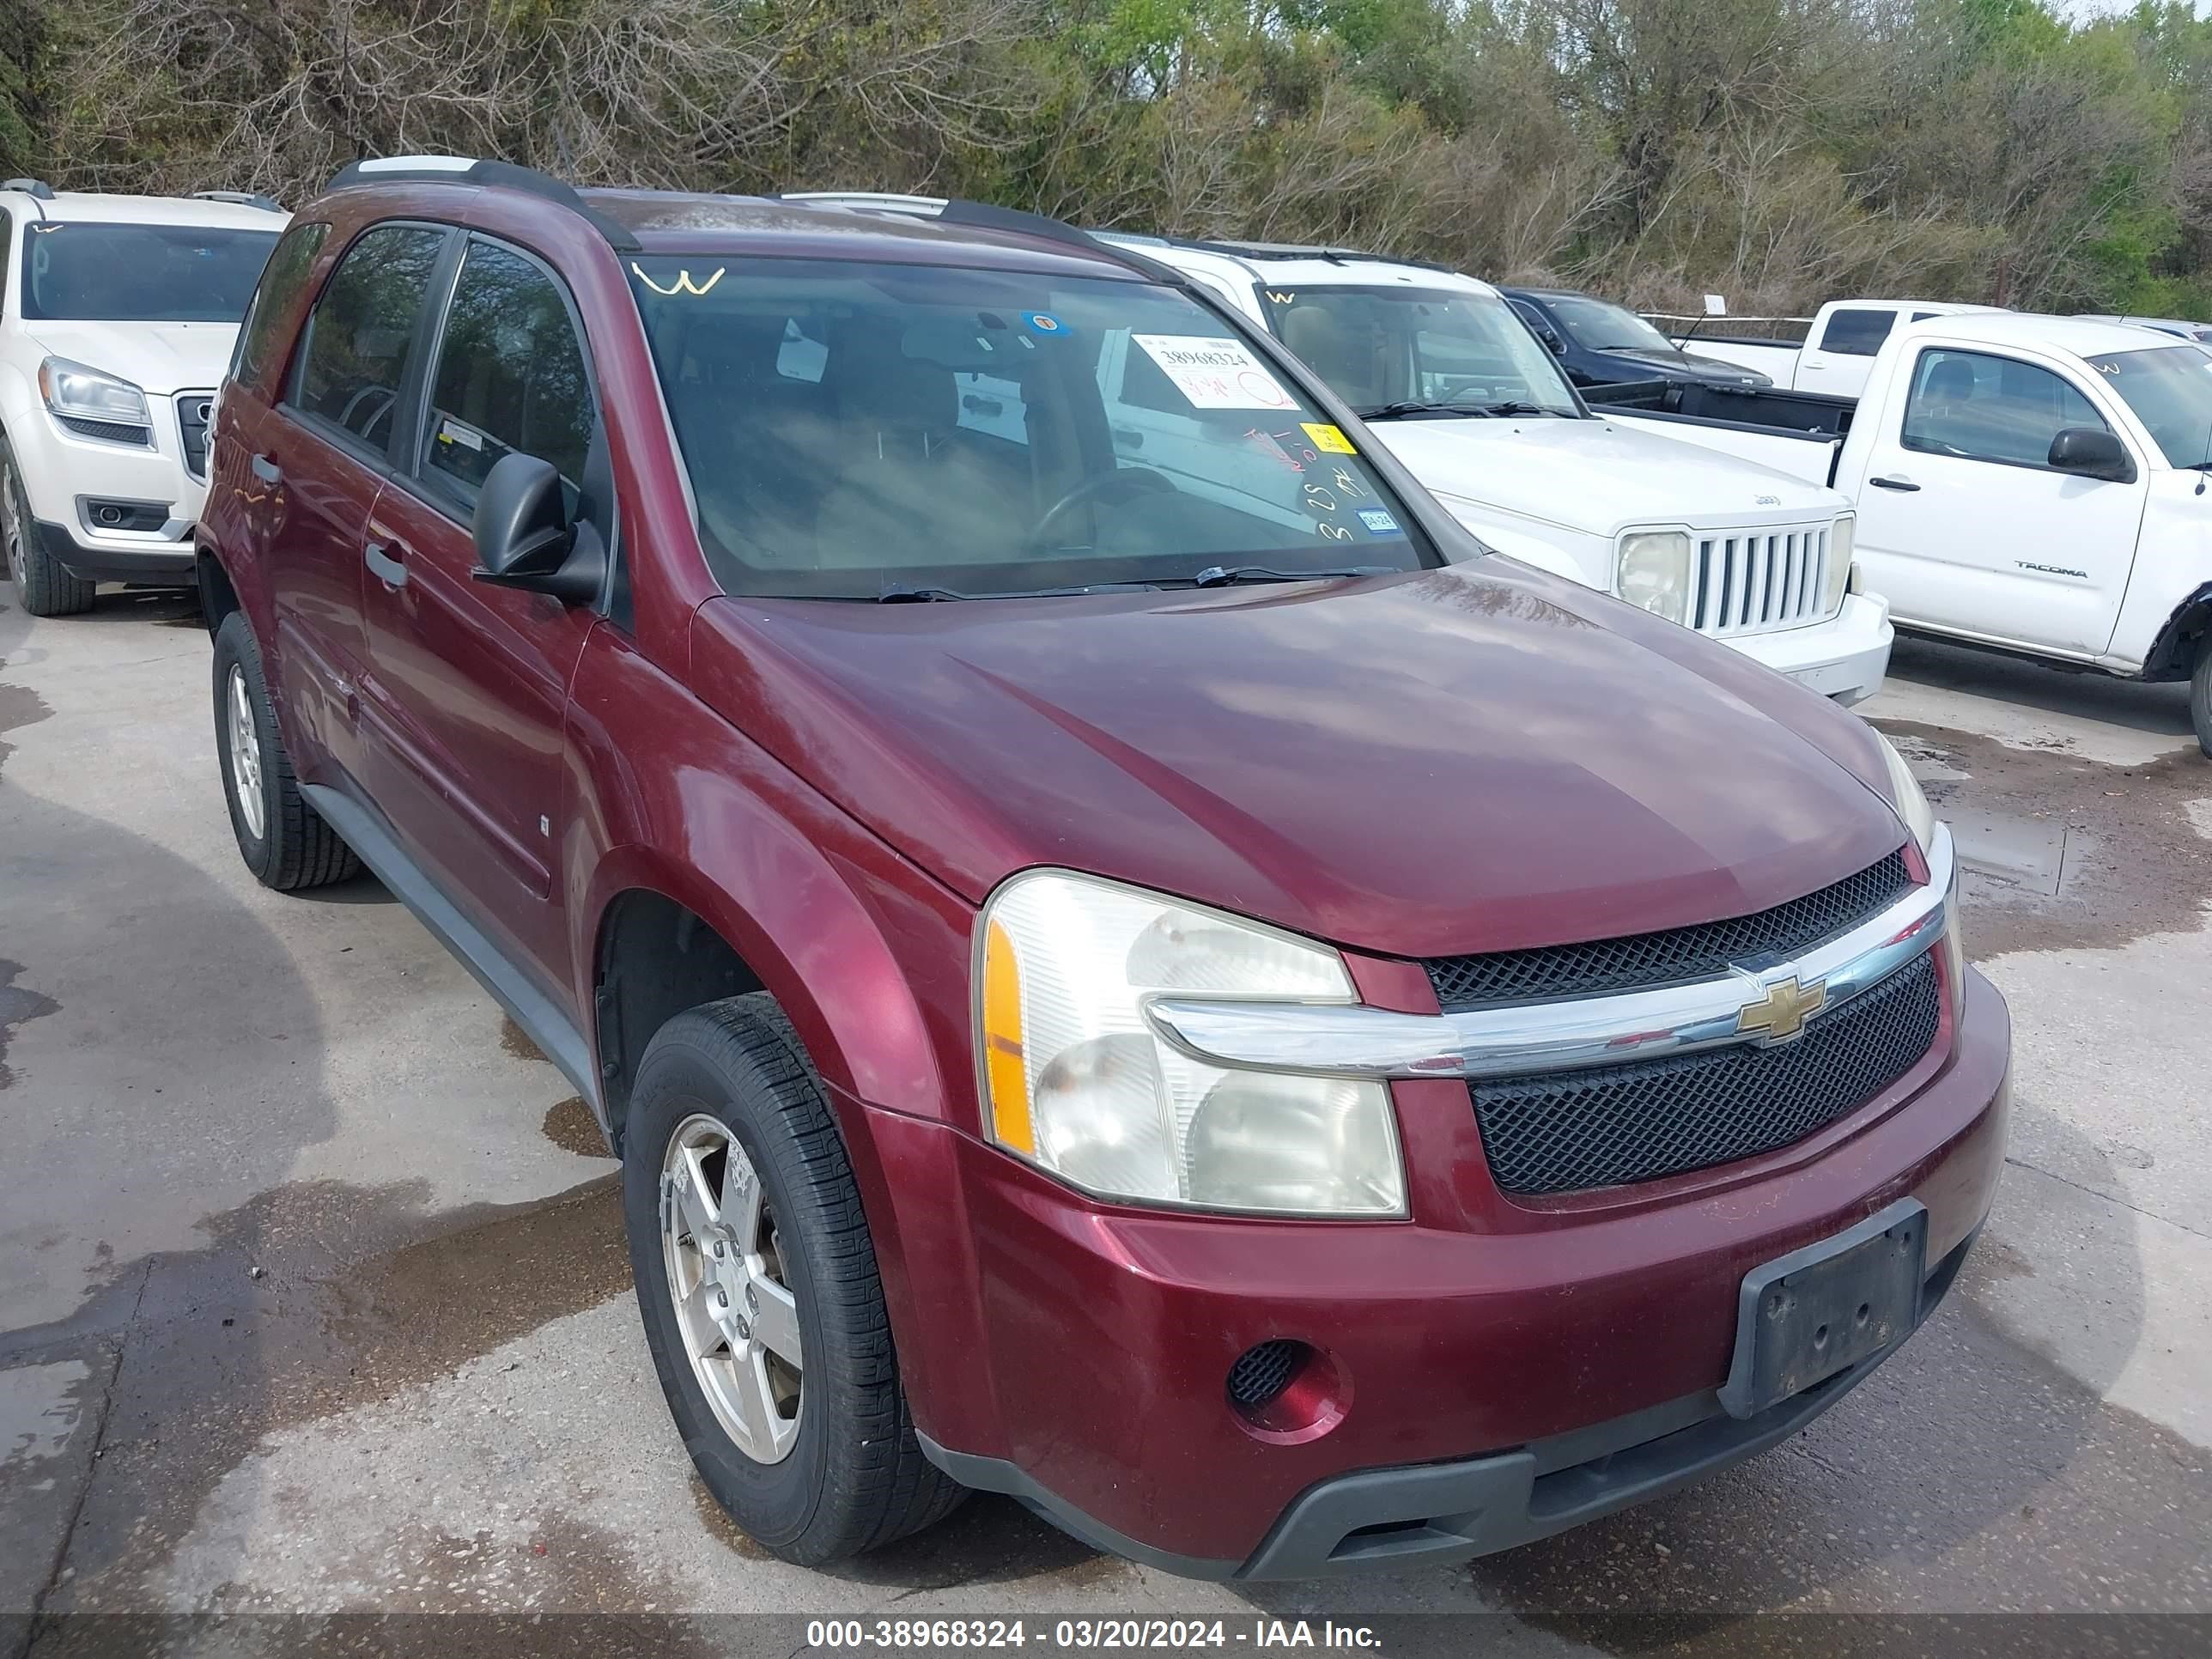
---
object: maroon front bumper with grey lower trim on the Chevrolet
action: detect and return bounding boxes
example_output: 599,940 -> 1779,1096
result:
863,975 -> 2011,1577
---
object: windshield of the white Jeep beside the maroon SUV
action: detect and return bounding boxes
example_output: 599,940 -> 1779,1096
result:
1263,288 -> 1582,418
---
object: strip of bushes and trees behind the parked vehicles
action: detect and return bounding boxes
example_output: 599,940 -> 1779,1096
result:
26,0 -> 2212,314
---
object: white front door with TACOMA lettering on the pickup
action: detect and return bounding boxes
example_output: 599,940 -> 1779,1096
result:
1858,345 -> 2148,657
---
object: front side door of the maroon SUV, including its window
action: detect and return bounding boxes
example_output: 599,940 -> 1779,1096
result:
356,234 -> 613,986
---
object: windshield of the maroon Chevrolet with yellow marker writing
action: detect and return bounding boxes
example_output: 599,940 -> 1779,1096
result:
630,257 -> 1436,599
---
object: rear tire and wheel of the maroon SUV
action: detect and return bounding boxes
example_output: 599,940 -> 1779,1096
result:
215,611 -> 361,894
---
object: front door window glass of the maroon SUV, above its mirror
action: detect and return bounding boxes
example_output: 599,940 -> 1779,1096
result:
422,239 -> 595,508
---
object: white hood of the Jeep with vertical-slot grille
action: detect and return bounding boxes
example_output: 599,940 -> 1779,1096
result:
1370,418 -> 1847,540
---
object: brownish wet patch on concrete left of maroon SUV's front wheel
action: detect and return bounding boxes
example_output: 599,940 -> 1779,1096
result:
23,1175 -> 630,1610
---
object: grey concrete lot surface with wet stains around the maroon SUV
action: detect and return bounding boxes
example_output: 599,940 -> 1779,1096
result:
0,592 -> 2212,1655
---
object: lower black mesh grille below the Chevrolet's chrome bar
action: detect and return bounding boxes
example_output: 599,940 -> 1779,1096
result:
1471,956 -> 1942,1194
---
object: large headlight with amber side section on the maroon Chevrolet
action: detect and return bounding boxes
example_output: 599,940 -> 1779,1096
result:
975,872 -> 1405,1217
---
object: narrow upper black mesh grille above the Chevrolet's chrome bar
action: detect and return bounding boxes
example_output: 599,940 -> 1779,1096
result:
1425,849 -> 1913,1013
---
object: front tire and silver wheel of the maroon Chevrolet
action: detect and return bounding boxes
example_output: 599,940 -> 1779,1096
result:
622,994 -> 967,1566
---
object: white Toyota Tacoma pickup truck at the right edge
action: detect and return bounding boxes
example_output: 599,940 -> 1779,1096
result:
1614,312 -> 2212,754
